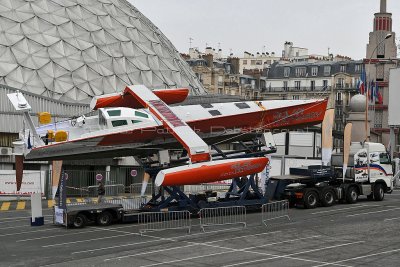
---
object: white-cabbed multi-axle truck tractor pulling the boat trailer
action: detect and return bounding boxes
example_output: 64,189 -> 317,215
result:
267,142 -> 398,209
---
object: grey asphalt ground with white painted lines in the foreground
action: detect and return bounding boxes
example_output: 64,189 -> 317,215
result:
0,191 -> 400,267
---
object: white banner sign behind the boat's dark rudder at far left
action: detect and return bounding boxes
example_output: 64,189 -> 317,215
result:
0,170 -> 46,196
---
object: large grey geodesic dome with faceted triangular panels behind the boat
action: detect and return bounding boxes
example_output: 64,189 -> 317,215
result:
0,0 -> 205,102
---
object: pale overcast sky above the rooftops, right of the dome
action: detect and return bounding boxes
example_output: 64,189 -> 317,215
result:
129,0 -> 400,59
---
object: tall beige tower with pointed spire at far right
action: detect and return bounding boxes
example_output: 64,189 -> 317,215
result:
364,0 -> 398,146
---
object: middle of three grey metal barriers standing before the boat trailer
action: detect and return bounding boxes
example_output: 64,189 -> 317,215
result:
198,206 -> 247,232
